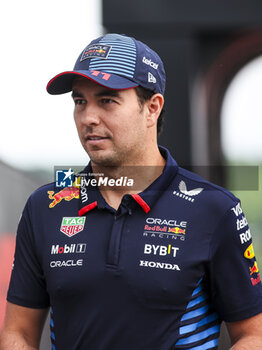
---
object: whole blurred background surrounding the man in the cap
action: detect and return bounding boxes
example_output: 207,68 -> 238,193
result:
0,0 -> 262,350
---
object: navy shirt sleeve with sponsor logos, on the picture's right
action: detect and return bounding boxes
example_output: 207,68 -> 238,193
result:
209,203 -> 262,322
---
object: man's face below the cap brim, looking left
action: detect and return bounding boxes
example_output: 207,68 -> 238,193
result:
72,78 -> 147,166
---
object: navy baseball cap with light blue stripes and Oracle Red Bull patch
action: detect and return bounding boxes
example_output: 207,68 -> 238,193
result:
47,34 -> 166,95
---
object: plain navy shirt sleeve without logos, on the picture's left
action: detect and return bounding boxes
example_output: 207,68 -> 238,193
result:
7,200 -> 50,308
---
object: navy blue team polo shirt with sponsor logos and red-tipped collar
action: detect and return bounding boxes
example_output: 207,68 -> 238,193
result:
7,148 -> 262,350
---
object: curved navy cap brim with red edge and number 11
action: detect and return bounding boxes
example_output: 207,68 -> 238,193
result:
46,70 -> 138,95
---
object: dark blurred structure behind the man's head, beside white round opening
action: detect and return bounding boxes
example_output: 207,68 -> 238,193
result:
103,0 -> 262,185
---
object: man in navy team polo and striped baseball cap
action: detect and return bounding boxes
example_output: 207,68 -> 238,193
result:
0,34 -> 262,350
